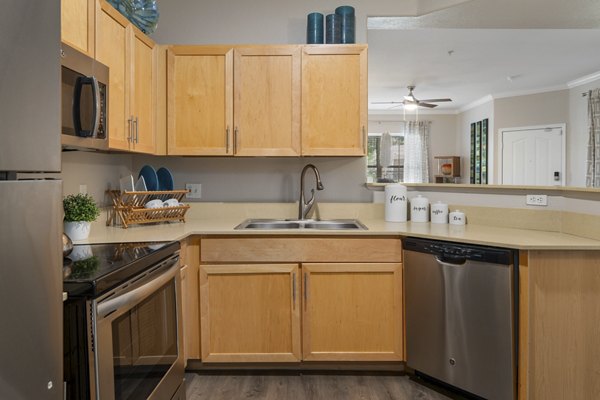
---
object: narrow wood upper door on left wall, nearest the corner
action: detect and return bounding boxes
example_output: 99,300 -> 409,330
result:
130,27 -> 156,154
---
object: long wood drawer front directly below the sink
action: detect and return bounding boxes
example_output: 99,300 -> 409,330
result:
200,236 -> 402,263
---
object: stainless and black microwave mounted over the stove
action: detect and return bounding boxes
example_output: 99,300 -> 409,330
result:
60,43 -> 108,150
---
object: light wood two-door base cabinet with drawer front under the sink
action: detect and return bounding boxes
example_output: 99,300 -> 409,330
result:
200,237 -> 404,362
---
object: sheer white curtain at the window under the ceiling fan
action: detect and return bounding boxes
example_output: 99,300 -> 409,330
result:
404,121 -> 431,183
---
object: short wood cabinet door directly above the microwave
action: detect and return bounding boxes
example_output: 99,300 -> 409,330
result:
60,0 -> 96,57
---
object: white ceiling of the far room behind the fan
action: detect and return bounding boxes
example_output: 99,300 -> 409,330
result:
367,28 -> 600,114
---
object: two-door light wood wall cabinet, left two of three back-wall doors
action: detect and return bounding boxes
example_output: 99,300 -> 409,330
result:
167,46 -> 301,156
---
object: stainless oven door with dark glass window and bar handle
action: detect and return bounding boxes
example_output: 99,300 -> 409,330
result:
92,255 -> 184,400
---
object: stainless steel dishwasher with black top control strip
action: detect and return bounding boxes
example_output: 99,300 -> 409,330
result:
404,238 -> 518,400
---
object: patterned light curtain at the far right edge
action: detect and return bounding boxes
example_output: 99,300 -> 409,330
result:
585,89 -> 600,187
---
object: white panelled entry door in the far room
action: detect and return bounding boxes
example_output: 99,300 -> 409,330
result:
500,126 -> 564,186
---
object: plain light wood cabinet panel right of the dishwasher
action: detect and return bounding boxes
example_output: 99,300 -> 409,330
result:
519,250 -> 600,400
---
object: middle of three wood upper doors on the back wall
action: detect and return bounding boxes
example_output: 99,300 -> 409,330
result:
233,46 -> 301,156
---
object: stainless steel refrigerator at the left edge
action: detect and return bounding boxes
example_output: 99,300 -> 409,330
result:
0,0 -> 63,400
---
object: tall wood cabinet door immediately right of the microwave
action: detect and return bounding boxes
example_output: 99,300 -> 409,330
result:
96,1 -> 131,150
